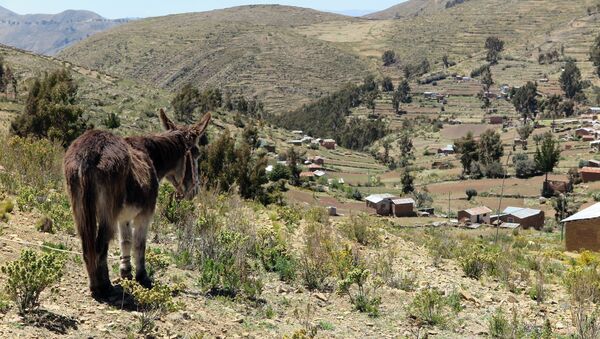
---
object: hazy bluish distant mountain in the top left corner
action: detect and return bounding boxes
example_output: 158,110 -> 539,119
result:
0,7 -> 128,55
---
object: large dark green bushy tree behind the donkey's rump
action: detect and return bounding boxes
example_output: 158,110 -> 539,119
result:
10,69 -> 92,147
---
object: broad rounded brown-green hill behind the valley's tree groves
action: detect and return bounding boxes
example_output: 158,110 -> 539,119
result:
60,6 -> 367,111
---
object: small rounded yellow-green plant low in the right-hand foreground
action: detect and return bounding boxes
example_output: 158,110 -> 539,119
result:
409,287 -> 447,326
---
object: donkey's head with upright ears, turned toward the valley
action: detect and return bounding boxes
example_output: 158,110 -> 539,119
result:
160,109 -> 211,199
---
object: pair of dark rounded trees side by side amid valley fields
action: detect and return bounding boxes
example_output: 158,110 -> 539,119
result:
455,130 -> 504,179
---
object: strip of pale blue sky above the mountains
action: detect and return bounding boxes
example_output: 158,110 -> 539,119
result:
0,0 -> 405,19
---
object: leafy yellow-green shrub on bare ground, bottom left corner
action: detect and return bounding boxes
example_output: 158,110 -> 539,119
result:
1,250 -> 65,314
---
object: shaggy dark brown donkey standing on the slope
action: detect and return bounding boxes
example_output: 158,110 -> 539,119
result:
64,109 -> 211,299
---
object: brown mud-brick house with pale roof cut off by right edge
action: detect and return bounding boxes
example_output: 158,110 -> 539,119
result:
562,203 -> 600,251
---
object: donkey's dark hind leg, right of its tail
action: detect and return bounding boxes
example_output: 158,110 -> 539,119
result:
94,220 -> 114,297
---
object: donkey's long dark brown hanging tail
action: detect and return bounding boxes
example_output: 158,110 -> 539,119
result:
70,171 -> 98,281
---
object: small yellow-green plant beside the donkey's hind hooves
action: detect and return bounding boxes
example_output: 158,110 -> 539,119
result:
121,280 -> 177,334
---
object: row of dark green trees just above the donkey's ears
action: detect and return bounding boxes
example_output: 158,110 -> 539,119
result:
171,84 -> 264,122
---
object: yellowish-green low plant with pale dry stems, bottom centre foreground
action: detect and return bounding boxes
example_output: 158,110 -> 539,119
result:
338,267 -> 382,317
